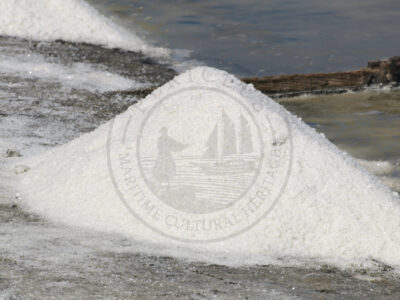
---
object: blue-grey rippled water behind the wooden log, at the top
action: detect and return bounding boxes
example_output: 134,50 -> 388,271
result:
89,0 -> 400,75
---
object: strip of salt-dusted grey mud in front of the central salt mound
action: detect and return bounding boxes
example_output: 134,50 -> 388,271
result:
0,197 -> 400,299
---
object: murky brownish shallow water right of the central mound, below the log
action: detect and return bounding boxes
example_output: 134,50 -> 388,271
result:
279,90 -> 400,192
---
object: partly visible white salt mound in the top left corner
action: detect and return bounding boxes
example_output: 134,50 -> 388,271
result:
0,0 -> 168,56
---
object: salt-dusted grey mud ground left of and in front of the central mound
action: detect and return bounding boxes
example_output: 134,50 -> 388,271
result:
0,38 -> 400,299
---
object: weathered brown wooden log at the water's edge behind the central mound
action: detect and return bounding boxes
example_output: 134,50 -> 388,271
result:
111,56 -> 400,98
